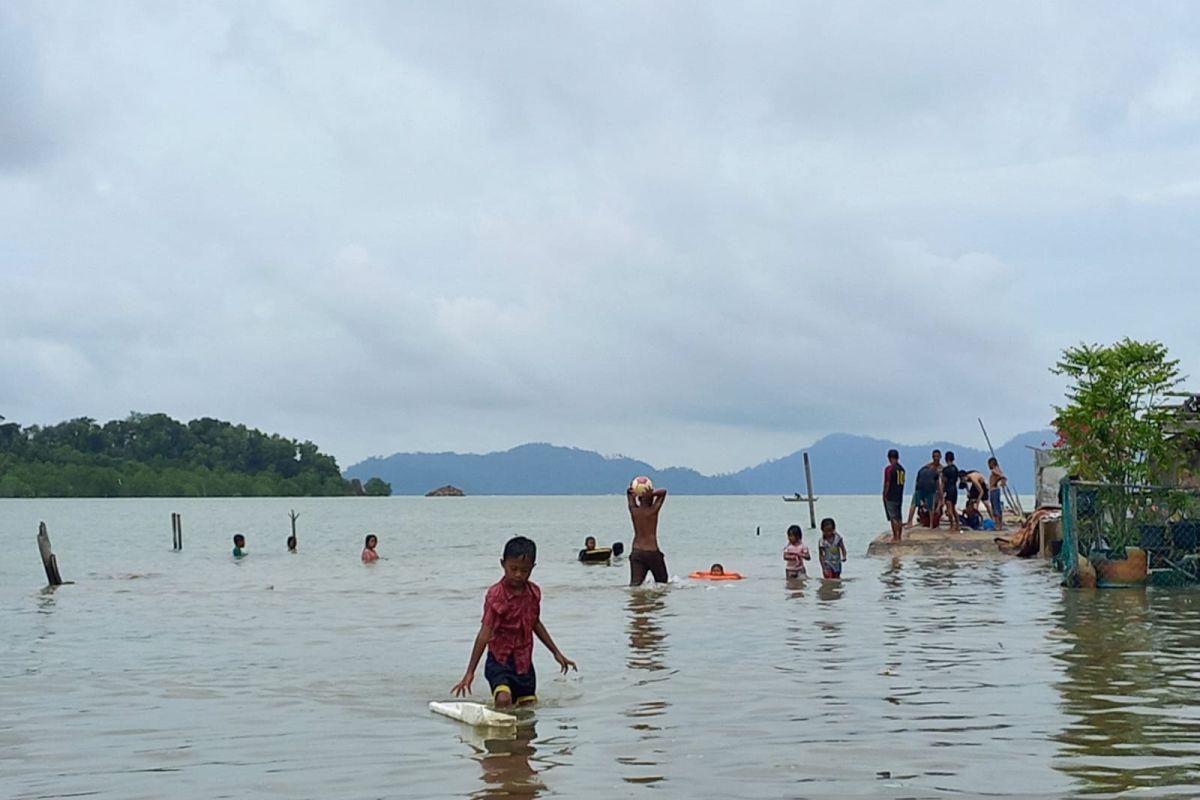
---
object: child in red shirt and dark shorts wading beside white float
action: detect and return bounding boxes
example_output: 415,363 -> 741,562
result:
451,536 -> 575,708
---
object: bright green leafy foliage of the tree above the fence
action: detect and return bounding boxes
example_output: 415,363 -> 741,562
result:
1051,337 -> 1183,483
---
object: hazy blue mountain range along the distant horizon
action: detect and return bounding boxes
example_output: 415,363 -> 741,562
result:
346,431 -> 1054,495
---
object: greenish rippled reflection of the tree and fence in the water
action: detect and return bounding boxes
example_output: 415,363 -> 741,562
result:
1055,590 -> 1200,793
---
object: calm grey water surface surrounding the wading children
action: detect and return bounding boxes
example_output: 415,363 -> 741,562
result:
0,497 -> 1200,800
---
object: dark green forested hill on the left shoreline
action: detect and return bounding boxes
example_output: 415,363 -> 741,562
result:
0,413 -> 388,498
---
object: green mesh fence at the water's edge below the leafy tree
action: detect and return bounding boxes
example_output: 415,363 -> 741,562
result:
1057,480 -> 1200,585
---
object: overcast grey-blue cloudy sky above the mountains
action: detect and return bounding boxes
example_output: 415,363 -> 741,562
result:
0,0 -> 1200,474
